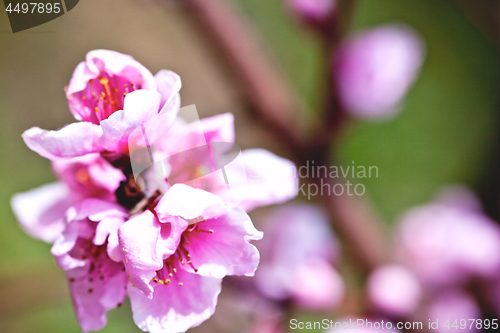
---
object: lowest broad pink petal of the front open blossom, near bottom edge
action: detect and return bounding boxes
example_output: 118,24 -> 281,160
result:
128,269 -> 221,333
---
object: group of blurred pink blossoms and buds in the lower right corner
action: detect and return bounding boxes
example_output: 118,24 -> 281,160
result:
367,185 -> 500,322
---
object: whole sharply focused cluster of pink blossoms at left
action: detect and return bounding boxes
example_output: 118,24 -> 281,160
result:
11,50 -> 297,333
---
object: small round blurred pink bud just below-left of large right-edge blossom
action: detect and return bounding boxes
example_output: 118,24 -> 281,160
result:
368,265 -> 422,317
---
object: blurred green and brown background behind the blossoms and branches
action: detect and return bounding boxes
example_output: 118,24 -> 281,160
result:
0,0 -> 500,333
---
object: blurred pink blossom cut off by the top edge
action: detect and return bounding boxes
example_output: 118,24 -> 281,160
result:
286,0 -> 337,24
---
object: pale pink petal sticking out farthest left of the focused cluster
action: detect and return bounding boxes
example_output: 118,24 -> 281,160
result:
11,182 -> 73,242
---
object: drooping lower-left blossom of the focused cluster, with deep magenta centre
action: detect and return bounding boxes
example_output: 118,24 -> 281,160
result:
52,199 -> 128,332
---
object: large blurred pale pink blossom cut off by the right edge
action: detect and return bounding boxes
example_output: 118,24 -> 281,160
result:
397,197 -> 500,286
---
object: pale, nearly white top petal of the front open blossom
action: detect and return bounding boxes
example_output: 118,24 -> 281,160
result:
155,184 -> 226,220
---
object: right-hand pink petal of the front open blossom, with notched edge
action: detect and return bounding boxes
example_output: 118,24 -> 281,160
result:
185,208 -> 263,278
